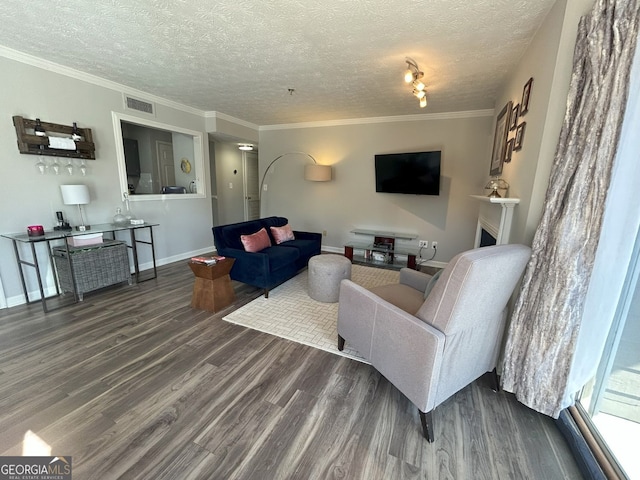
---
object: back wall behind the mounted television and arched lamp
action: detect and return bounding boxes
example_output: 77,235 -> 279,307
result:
259,112 -> 493,262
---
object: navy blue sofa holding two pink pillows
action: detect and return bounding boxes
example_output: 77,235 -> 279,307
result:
212,217 -> 322,298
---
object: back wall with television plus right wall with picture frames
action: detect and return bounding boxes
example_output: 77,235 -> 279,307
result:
254,0 -> 593,262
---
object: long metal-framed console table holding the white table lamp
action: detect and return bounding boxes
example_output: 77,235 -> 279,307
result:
1,222 -> 158,312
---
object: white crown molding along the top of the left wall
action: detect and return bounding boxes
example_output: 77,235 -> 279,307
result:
0,45 -> 205,117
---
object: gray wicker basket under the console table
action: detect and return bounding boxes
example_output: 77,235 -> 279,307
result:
53,240 -> 131,300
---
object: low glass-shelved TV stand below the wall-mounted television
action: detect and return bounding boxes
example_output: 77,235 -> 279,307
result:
344,229 -> 418,269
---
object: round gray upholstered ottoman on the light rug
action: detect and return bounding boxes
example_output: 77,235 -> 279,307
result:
309,254 -> 351,303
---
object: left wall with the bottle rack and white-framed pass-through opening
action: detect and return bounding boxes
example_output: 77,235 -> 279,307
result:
0,57 -> 213,305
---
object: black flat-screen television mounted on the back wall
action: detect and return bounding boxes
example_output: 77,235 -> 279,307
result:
375,151 -> 441,195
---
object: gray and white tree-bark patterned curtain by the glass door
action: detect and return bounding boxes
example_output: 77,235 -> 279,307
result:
502,0 -> 640,418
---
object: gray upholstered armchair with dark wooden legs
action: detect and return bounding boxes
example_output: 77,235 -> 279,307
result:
338,245 -> 531,442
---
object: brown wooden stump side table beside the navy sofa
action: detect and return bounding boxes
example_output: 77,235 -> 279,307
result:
189,258 -> 236,313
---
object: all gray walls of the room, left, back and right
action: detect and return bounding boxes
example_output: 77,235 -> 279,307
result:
0,0 -> 593,305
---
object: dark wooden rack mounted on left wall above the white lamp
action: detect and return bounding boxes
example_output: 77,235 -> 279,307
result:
13,115 -> 96,160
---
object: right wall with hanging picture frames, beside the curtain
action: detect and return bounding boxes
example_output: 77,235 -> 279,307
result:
494,0 -> 594,248
